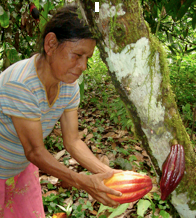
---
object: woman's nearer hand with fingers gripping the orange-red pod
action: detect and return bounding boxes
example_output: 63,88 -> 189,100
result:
77,171 -> 122,207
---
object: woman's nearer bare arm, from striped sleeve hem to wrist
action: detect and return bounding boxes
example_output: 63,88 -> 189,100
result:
12,117 -> 82,188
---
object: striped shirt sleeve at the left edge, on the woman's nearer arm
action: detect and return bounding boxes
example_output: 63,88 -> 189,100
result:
0,81 -> 41,120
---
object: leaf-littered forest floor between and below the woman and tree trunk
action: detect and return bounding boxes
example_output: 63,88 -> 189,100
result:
40,71 -> 178,218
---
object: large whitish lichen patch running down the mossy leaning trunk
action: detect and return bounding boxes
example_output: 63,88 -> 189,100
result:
105,37 -> 172,169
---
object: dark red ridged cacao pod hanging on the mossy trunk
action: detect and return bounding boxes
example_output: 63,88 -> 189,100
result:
160,144 -> 185,200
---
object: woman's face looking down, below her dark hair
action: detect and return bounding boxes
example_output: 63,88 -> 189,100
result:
49,39 -> 96,83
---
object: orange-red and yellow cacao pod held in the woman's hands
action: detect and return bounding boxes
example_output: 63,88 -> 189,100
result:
104,171 -> 152,204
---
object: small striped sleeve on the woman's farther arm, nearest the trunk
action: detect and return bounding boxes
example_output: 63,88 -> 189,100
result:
65,81 -> 80,111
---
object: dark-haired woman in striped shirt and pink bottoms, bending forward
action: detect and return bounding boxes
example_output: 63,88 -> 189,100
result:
0,3 -> 121,218
